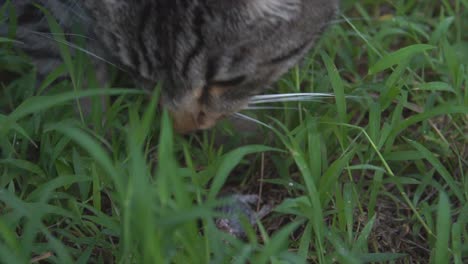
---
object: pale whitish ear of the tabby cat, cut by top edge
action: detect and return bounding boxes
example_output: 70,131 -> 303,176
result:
240,0 -> 302,20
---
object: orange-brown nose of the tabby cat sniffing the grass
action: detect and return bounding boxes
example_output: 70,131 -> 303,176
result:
169,111 -> 222,134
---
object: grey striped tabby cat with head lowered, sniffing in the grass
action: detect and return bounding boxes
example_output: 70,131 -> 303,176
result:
5,0 -> 338,133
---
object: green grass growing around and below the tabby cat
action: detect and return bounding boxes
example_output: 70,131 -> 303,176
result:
0,0 -> 468,264
